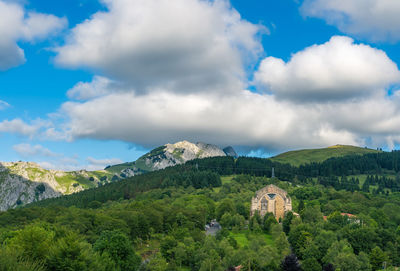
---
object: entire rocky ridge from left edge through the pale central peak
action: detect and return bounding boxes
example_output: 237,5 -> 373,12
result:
0,141 -> 236,211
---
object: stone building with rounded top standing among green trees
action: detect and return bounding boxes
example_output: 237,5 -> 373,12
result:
250,184 -> 292,220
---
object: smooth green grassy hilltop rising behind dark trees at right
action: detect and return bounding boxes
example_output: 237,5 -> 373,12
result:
271,145 -> 379,166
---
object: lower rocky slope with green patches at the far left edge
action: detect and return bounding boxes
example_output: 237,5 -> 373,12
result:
0,162 -> 113,211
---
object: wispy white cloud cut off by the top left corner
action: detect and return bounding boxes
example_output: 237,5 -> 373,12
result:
0,0 -> 67,71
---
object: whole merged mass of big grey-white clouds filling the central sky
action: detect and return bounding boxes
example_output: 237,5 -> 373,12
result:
6,0 -> 400,154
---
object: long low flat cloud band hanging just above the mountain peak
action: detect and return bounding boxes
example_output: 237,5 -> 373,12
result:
62,88 -> 400,151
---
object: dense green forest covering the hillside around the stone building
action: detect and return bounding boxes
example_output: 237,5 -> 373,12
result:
0,152 -> 400,271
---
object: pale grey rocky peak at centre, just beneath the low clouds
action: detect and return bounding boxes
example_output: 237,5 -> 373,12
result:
105,140 -> 233,178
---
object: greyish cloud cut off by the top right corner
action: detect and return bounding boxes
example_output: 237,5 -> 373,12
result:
301,0 -> 400,41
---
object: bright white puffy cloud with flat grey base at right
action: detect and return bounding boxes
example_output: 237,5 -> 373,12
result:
255,36 -> 400,101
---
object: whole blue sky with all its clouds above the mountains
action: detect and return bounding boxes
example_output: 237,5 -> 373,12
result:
0,0 -> 400,170
